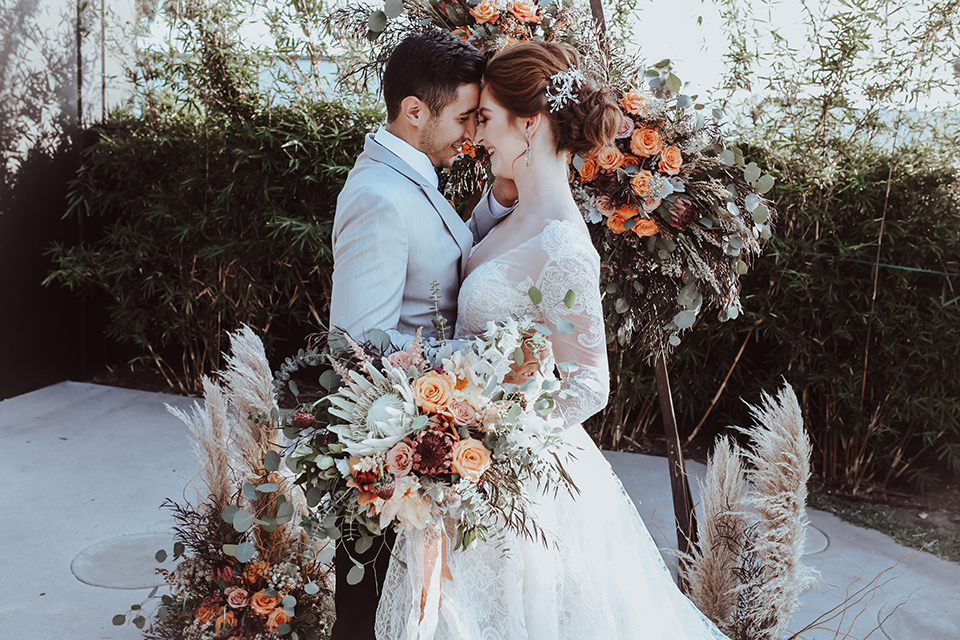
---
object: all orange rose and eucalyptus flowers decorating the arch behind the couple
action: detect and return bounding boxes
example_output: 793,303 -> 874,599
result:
331,0 -> 774,358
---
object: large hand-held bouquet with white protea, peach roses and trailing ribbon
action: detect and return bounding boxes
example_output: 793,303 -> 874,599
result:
285,321 -> 575,580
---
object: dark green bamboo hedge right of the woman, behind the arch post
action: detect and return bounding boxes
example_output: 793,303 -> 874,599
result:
593,149 -> 960,491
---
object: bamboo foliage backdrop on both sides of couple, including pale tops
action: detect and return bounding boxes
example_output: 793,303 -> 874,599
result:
49,0 -> 960,491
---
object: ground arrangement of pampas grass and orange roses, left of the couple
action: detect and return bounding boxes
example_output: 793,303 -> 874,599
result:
113,327 -> 334,640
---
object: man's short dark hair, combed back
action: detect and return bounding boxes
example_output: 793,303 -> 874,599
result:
383,29 -> 486,122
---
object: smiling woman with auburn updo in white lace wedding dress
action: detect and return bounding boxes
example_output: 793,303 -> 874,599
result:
376,42 -> 726,640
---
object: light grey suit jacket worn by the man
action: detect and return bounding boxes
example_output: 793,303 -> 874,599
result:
330,135 -> 498,347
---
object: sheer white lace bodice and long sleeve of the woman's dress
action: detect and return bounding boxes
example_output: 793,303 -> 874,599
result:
456,220 -> 609,425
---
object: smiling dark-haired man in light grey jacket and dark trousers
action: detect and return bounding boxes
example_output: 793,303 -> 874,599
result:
330,30 -> 516,640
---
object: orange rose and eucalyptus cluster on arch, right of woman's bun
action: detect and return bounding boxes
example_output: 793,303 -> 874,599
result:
571,65 -> 773,356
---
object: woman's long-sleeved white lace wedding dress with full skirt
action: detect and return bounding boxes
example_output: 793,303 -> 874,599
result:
376,220 -> 726,640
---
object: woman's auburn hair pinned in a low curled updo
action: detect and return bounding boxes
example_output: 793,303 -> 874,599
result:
483,42 -> 621,155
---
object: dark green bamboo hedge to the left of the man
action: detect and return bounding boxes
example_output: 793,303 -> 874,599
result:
48,103 -> 380,391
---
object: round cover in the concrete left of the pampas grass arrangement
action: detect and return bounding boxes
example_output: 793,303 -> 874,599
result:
70,533 -> 174,589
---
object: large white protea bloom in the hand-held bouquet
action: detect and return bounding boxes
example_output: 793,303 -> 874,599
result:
330,363 -> 417,456
